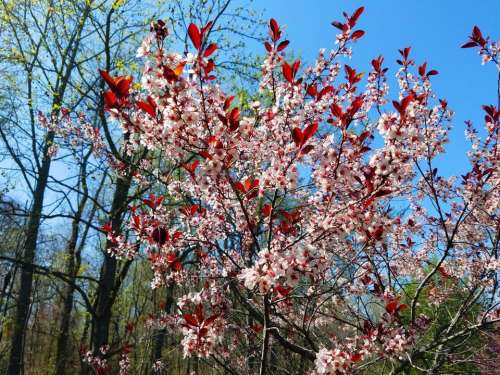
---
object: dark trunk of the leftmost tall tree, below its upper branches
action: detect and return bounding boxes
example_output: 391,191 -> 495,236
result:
7,132 -> 54,375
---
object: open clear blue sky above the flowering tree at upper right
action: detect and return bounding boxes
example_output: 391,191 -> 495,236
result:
254,0 -> 500,175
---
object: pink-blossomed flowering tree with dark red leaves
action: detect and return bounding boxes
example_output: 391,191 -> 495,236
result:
93,8 -> 500,374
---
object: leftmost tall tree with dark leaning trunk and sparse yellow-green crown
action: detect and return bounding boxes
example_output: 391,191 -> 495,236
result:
0,0 -> 93,375
